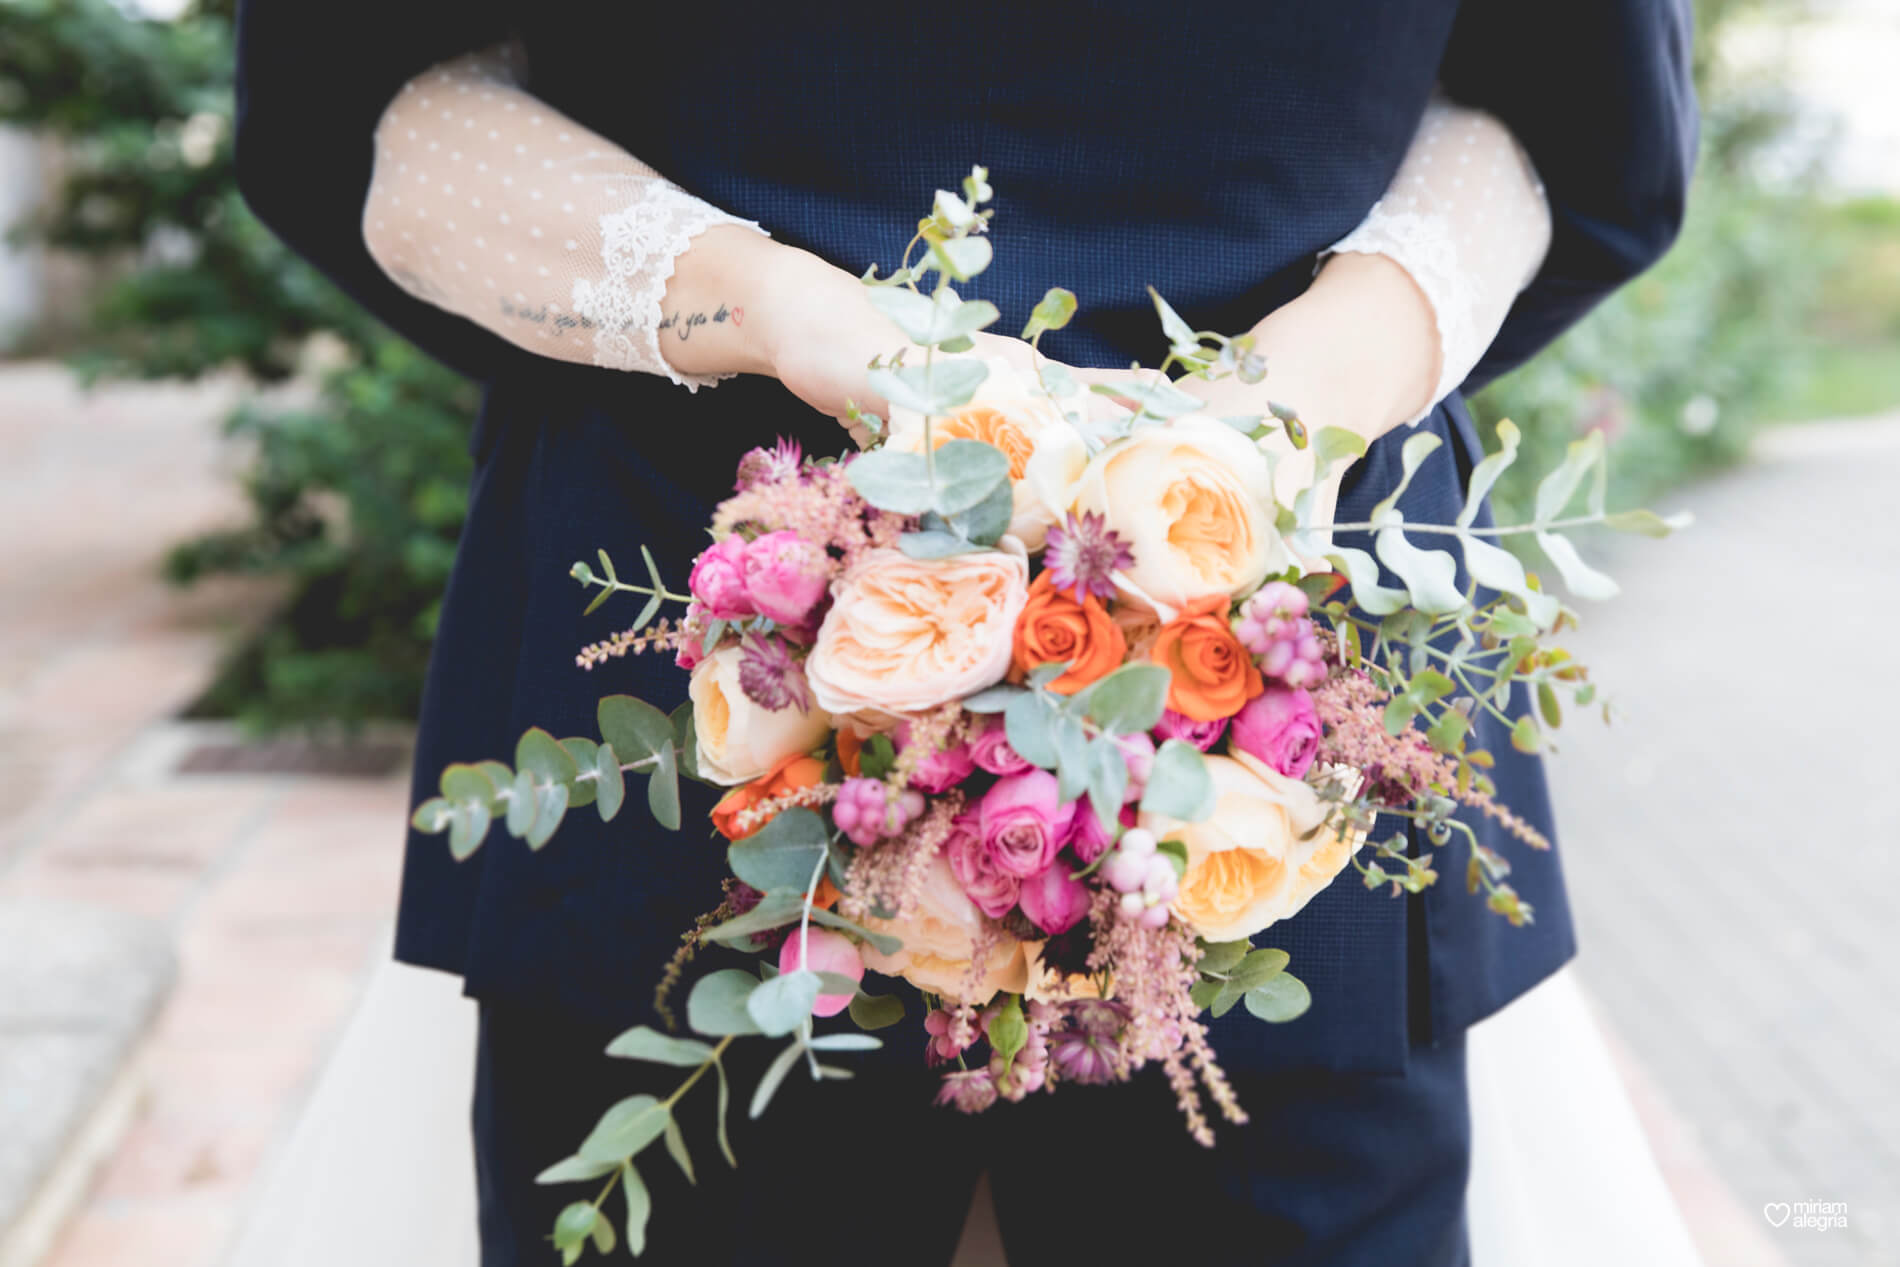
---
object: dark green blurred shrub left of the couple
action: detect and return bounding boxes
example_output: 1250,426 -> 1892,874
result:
0,0 -> 475,728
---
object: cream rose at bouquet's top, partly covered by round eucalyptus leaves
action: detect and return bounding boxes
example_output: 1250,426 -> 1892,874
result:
889,357 -> 1089,551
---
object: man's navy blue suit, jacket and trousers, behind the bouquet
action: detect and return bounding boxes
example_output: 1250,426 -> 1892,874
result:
238,0 -> 1697,1263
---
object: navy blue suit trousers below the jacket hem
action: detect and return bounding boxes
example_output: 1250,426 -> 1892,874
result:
473,1003 -> 1471,1267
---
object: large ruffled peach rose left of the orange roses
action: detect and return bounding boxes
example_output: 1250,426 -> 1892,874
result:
806,538 -> 1030,714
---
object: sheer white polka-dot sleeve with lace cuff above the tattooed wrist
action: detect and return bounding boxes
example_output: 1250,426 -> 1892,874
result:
363,51 -> 762,389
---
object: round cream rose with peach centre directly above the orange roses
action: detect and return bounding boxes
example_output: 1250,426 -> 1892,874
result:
1075,414 -> 1292,610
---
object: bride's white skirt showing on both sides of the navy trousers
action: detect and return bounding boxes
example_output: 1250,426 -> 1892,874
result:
230,961 -> 1701,1267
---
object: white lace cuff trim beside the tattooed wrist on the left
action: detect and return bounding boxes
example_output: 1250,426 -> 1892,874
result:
574,180 -> 766,391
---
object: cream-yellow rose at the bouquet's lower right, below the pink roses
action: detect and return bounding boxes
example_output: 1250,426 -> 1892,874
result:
1142,752 -> 1362,942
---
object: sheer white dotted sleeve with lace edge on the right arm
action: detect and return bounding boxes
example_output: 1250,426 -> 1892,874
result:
1328,97 -> 1550,422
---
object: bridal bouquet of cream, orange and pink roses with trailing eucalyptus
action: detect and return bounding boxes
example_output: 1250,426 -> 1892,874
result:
414,169 -> 1674,1263
